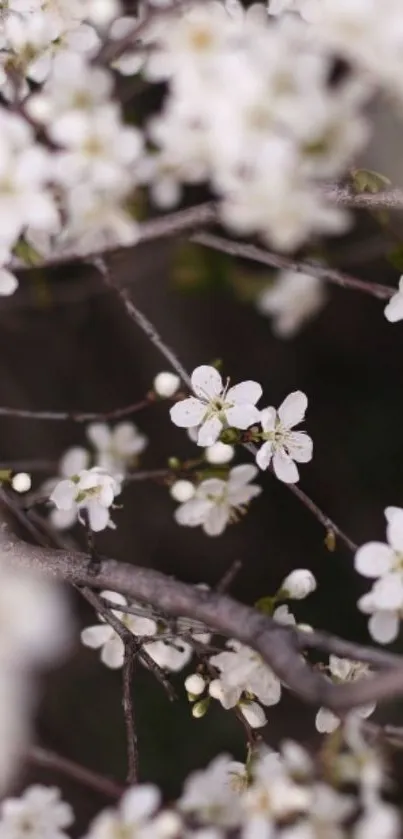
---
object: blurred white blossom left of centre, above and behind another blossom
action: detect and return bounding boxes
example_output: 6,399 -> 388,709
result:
86,422 -> 148,478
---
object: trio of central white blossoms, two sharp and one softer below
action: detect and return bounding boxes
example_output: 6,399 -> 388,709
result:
170,365 -> 313,512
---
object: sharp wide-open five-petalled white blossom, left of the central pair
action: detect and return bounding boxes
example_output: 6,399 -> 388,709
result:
170,365 -> 262,446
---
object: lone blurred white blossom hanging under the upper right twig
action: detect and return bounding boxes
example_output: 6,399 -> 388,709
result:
256,271 -> 326,338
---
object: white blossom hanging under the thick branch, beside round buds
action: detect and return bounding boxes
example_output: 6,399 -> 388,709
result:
209,640 -> 281,709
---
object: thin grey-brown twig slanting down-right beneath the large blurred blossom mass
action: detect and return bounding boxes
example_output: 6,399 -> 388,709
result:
190,233 -> 396,300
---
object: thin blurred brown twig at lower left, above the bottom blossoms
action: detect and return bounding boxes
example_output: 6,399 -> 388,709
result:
27,746 -> 124,798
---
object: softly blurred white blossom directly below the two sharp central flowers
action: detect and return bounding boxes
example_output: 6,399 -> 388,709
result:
175,464 -> 261,536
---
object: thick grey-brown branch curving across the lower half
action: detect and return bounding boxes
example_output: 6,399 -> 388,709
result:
4,524 -> 403,713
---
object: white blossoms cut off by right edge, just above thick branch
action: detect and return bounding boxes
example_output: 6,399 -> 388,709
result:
355,507 -> 403,644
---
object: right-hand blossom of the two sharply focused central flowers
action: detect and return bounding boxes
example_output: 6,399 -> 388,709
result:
256,390 -> 313,484
